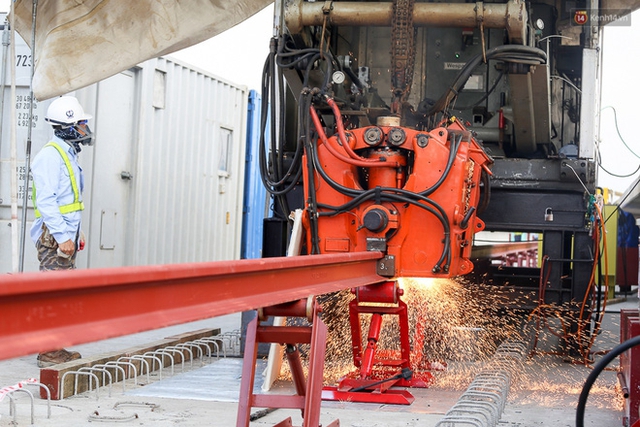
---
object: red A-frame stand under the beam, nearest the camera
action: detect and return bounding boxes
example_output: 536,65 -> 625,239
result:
236,297 -> 340,427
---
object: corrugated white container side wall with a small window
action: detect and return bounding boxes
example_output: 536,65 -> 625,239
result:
126,58 -> 248,265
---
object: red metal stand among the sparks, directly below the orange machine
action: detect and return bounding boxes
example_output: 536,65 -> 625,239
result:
322,281 -> 433,405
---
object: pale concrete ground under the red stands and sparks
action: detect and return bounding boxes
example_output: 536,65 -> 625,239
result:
0,296 -> 638,427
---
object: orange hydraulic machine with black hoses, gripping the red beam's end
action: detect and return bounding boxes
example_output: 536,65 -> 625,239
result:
303,98 -> 492,277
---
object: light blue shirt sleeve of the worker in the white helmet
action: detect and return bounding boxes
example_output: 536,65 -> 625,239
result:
31,147 -> 75,243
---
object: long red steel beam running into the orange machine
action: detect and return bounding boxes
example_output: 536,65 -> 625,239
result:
0,252 -> 386,360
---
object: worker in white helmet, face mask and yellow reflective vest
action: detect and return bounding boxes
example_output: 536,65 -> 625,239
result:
31,96 -> 93,368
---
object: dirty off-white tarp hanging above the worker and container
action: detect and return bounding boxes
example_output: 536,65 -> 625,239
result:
14,0 -> 273,101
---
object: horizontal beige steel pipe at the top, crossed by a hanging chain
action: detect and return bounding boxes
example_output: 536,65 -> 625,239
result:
285,0 -> 527,43
